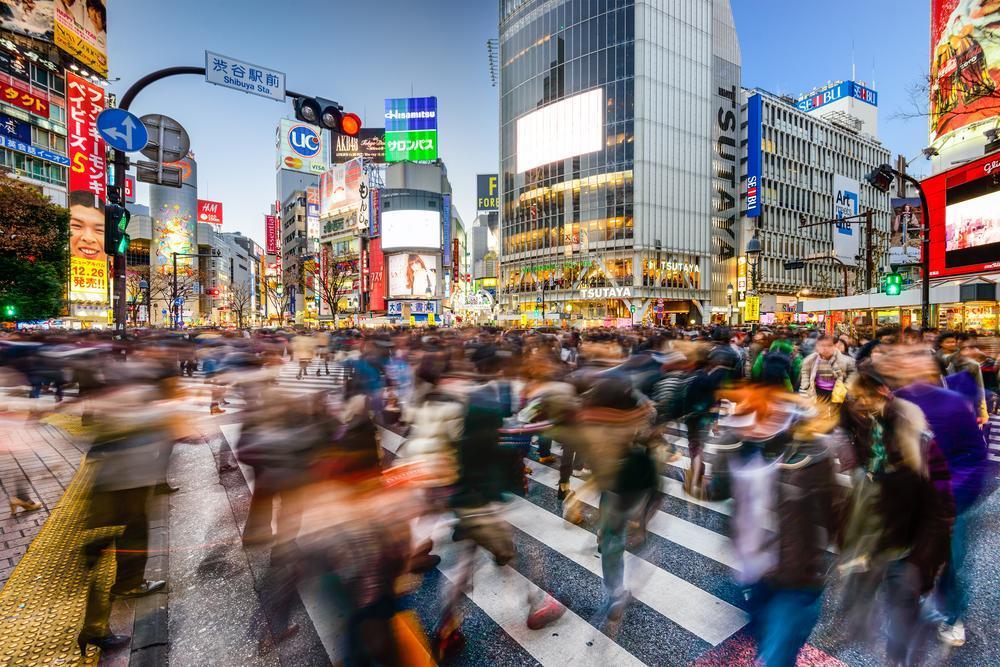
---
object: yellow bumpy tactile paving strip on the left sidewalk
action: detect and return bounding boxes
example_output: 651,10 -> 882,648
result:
0,419 -> 114,667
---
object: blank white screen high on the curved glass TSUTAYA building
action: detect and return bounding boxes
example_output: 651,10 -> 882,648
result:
517,88 -> 606,173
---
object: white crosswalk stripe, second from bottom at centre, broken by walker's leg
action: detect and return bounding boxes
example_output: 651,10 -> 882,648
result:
505,497 -> 748,646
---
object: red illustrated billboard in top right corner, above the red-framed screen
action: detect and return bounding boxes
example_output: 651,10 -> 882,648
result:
930,0 -> 1000,142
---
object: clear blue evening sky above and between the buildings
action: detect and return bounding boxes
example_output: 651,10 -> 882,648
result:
108,0 -> 929,242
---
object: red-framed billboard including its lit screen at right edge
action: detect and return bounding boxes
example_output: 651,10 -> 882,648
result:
922,153 -> 1000,277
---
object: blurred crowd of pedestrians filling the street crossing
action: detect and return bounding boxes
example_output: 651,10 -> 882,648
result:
0,326 -> 998,666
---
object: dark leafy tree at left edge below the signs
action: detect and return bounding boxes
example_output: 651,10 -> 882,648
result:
0,173 -> 69,320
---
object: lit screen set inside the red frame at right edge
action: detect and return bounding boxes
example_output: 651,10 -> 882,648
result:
944,177 -> 1000,269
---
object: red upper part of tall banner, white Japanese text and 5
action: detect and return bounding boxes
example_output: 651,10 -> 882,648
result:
66,71 -> 108,201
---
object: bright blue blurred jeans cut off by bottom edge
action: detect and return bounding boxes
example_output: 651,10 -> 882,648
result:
748,583 -> 823,667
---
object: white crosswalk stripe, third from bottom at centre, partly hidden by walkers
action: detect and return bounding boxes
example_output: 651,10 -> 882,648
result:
525,461 -> 738,569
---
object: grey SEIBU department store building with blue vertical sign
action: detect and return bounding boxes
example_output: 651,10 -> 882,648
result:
744,88 -> 891,323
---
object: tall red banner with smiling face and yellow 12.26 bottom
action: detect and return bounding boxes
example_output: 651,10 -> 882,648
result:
66,72 -> 108,303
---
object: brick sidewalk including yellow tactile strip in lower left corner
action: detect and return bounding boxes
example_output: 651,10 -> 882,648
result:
0,414 -> 168,667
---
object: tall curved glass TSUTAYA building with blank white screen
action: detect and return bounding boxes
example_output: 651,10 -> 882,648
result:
499,0 -> 741,326
